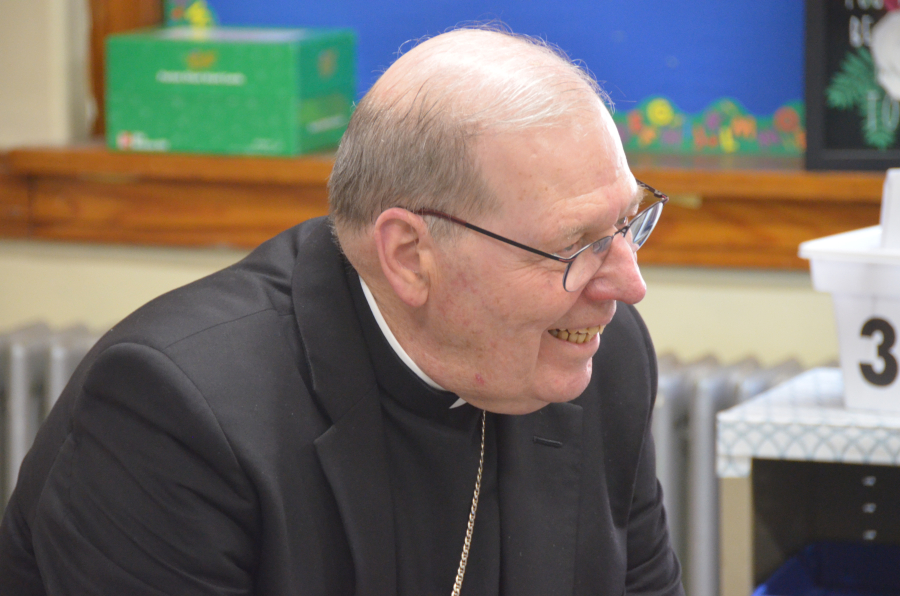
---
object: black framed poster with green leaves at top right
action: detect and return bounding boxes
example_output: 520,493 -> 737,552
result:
806,0 -> 900,170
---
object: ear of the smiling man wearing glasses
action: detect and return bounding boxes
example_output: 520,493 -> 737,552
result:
373,207 -> 433,307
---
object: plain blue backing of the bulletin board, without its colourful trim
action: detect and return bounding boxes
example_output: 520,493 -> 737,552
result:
186,0 -> 805,115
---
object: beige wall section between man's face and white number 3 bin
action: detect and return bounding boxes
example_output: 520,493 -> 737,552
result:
639,267 -> 838,366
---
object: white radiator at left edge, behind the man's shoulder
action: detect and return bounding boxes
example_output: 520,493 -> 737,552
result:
0,323 -> 98,512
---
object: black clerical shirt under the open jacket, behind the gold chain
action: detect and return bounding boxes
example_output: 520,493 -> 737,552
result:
349,274 -> 501,596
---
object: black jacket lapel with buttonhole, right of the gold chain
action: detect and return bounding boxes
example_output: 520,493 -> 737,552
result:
498,403 -> 582,596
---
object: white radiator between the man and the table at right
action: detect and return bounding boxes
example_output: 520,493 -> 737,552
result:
653,354 -> 802,596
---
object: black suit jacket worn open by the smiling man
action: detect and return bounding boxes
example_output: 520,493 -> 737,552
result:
0,219 -> 682,596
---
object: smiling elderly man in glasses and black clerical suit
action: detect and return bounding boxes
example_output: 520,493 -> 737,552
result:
0,30 -> 682,596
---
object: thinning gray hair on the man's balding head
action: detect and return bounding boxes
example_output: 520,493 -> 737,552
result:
328,27 -> 611,234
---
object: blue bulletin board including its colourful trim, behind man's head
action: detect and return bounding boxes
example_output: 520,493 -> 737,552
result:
166,0 -> 805,155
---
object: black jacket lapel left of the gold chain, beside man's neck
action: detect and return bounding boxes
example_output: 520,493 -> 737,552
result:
292,220 -> 397,596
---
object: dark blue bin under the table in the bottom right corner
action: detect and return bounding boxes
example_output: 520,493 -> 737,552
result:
753,542 -> 900,596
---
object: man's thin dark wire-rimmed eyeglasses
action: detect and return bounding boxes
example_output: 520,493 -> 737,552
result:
413,180 -> 669,292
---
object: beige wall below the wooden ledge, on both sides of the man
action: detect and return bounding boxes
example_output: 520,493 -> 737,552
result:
0,241 -> 837,366
